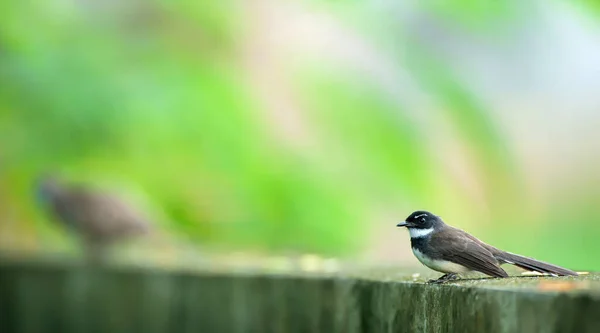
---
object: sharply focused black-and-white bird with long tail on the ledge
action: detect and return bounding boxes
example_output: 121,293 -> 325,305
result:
396,210 -> 578,284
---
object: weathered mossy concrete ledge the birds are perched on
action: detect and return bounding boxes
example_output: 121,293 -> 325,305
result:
0,260 -> 600,333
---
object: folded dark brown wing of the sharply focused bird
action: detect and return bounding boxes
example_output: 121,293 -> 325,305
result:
429,227 -> 508,277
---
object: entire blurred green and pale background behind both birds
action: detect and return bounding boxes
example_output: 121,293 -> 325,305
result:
0,0 -> 600,270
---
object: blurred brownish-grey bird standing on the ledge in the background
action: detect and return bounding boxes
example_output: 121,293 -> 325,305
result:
34,174 -> 151,263
